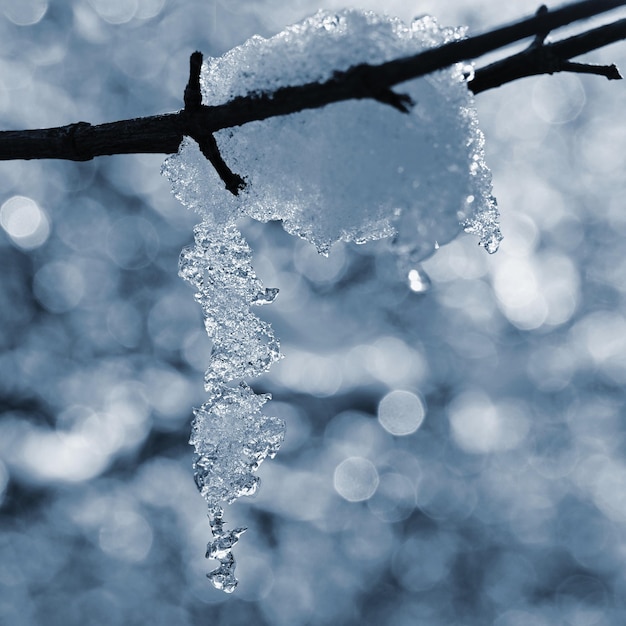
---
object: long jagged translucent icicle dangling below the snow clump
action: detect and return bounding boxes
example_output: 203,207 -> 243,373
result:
179,219 -> 284,593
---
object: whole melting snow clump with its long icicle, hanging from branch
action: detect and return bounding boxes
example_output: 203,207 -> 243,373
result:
163,10 -> 502,591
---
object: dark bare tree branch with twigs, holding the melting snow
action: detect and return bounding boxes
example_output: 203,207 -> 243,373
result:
0,0 -> 626,185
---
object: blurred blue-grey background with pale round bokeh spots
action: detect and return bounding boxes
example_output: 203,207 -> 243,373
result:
0,0 -> 626,626
